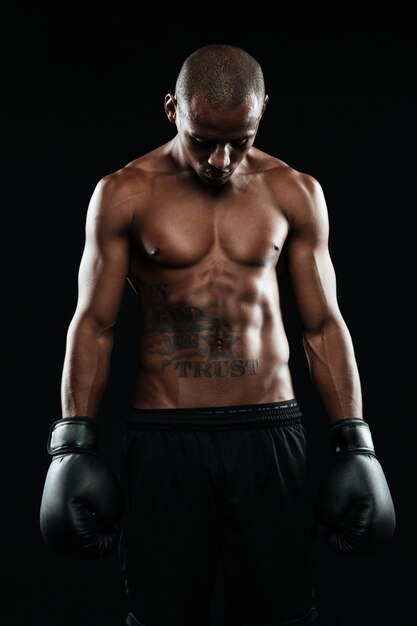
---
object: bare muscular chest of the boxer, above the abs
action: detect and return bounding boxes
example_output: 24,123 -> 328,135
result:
133,192 -> 288,267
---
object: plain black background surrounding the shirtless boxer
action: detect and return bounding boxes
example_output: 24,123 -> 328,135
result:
1,6 -> 417,626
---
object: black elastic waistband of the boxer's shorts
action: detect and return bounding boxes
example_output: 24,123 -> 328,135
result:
126,399 -> 302,430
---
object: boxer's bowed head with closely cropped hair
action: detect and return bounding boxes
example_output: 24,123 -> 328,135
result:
165,44 -> 268,186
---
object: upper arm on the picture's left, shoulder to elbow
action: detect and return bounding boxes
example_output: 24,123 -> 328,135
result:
74,176 -> 131,331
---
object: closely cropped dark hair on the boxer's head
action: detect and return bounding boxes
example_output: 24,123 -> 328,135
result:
175,44 -> 265,111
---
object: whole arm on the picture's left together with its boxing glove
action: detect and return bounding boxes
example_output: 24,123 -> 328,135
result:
40,176 -> 130,558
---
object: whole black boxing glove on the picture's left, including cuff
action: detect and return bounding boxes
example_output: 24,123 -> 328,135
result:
40,417 -> 123,558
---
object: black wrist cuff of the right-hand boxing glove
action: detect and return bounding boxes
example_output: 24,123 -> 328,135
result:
329,418 -> 375,456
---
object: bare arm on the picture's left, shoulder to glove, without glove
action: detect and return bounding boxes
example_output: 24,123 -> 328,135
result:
61,177 -> 130,418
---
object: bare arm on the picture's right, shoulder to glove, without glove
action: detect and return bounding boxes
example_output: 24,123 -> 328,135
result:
288,175 -> 362,422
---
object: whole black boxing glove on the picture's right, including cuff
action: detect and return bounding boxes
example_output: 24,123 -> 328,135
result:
315,418 -> 396,556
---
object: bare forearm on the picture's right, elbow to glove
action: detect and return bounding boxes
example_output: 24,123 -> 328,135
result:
303,321 -> 362,421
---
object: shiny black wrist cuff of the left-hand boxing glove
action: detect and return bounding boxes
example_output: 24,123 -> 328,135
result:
47,417 -> 98,456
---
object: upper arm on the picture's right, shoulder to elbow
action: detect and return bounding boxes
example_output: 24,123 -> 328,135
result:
287,174 -> 342,332
